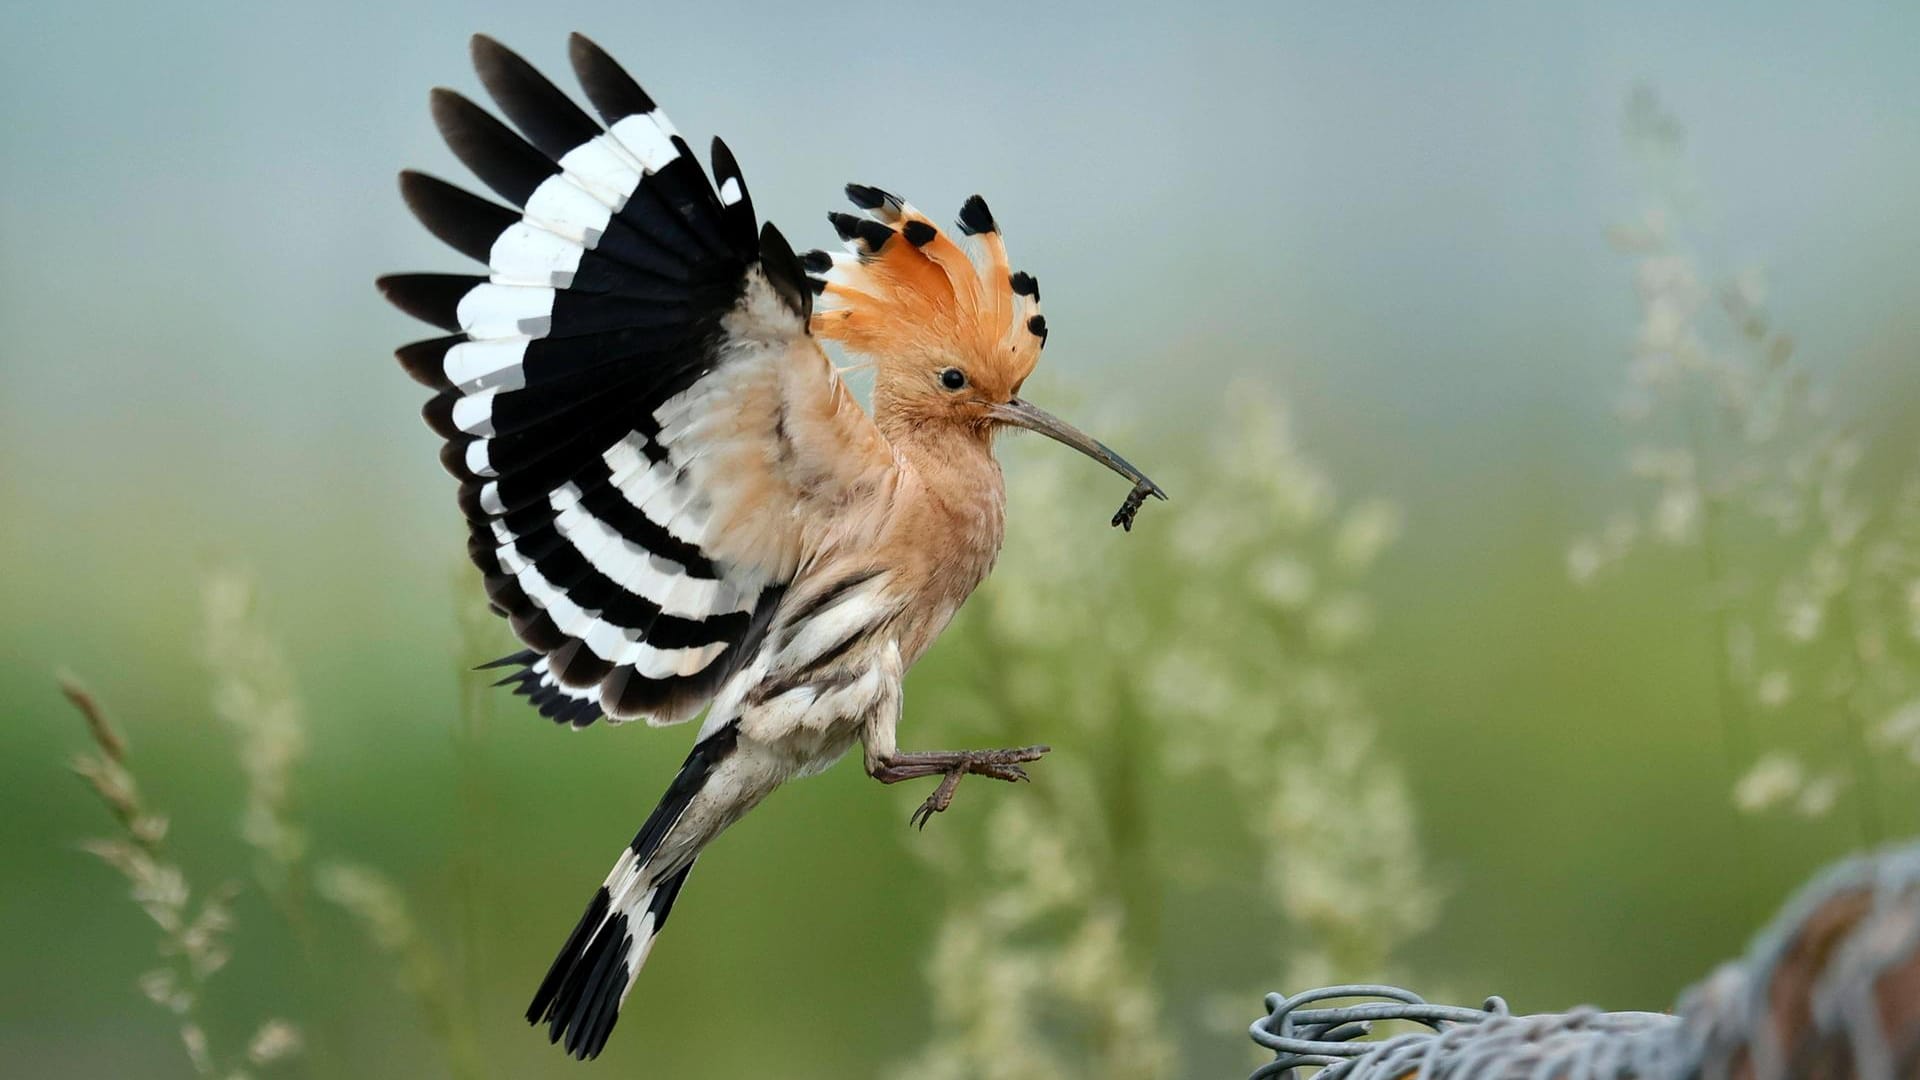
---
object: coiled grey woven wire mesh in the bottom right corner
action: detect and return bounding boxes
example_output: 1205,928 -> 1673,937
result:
1252,844 -> 1920,1080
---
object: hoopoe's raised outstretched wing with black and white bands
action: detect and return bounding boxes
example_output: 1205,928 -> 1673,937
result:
380,35 -> 897,726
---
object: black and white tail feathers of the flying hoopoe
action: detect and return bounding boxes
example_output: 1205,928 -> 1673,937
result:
526,721 -> 739,1061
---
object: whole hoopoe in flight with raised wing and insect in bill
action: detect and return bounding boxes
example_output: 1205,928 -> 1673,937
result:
368,35 -> 1165,1059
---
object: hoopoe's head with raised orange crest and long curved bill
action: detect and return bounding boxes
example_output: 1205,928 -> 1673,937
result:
801,184 -> 1165,498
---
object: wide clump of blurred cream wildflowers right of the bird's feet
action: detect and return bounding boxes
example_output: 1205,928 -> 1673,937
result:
899,388 -> 1436,1080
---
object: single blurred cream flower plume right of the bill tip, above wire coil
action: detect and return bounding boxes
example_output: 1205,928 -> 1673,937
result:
1164,394 -> 1438,984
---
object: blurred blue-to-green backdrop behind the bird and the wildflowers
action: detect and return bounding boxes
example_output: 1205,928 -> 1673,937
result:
0,2 -> 1920,1076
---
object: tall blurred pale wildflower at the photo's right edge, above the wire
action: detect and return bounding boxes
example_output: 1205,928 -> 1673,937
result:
1567,86 -> 1920,842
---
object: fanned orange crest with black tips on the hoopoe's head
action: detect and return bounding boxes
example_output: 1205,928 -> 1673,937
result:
801,184 -> 1046,394
